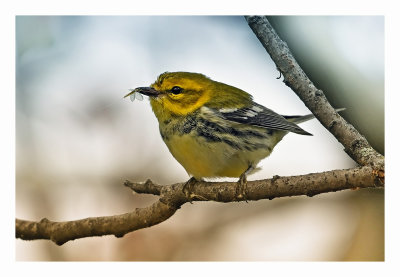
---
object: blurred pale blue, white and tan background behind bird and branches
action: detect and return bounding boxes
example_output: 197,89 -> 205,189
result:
15,16 -> 384,261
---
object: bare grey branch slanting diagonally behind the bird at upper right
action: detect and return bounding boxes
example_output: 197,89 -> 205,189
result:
245,16 -> 385,170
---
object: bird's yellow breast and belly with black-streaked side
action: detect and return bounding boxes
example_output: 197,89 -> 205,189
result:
156,111 -> 282,178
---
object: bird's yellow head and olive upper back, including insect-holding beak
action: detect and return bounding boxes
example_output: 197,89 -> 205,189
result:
125,72 -> 252,119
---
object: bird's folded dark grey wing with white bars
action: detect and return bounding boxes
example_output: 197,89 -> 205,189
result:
214,102 -> 311,135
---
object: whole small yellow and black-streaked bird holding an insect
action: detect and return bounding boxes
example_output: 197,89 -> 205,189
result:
125,72 -> 314,198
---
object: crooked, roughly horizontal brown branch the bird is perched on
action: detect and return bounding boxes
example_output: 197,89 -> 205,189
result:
15,166 -> 384,245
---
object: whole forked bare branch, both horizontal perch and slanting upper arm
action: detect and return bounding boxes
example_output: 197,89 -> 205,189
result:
16,16 -> 385,245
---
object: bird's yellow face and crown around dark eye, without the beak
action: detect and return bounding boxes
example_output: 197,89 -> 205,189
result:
150,72 -> 213,117
